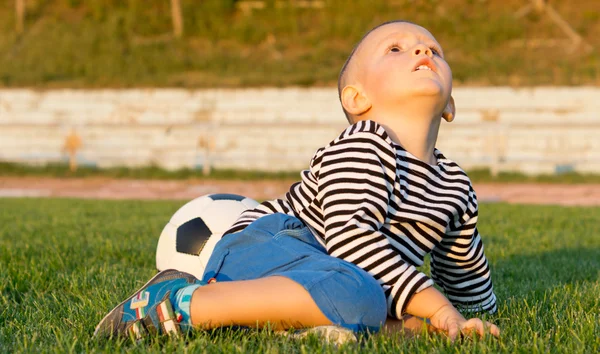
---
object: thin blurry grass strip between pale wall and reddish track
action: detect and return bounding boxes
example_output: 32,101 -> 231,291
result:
0,162 -> 600,184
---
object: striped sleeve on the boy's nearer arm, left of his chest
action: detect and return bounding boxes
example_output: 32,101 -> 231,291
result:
313,128 -> 433,318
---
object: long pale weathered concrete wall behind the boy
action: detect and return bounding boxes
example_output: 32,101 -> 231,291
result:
0,87 -> 600,173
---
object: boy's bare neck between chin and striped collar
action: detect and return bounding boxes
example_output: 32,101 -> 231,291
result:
362,108 -> 441,165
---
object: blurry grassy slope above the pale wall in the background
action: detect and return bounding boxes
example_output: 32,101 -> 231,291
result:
0,0 -> 600,88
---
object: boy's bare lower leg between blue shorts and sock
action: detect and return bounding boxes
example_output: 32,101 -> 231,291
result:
191,276 -> 332,330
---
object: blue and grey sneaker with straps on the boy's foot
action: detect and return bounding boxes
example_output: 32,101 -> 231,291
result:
94,269 -> 204,339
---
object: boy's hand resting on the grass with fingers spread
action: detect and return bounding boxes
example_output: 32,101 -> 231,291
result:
430,305 -> 500,341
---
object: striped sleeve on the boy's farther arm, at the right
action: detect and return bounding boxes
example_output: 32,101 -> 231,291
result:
431,187 -> 497,313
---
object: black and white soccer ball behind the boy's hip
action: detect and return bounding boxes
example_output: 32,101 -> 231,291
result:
156,194 -> 258,279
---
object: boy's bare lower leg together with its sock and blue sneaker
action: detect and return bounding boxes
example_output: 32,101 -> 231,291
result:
94,269 -> 331,338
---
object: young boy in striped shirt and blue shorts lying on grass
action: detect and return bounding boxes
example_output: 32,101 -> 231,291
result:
95,21 -> 499,338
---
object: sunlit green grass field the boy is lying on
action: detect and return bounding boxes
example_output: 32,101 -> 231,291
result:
0,199 -> 600,353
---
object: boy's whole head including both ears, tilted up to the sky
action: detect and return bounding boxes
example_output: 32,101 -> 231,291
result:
338,21 -> 454,123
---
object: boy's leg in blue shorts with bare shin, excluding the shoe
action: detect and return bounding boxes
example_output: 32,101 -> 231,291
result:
197,214 -> 387,332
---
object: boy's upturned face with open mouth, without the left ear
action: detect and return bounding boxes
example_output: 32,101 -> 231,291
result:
355,22 -> 452,112
